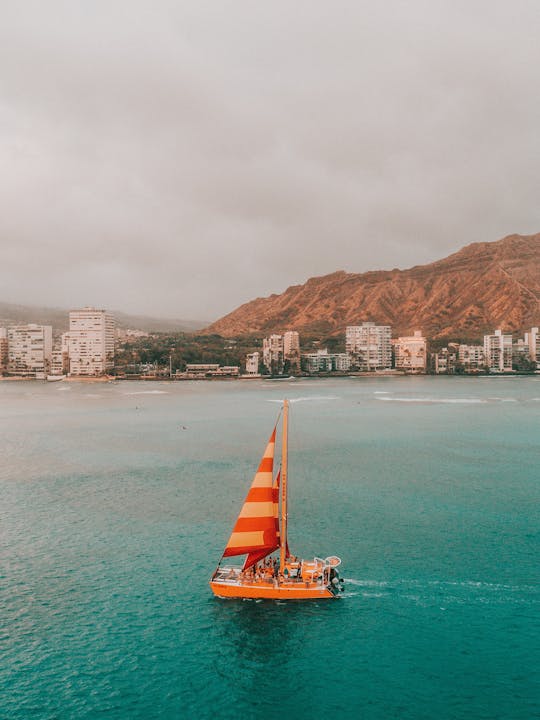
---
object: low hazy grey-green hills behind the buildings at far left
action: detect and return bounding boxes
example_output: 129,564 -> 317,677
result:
0,302 -> 206,332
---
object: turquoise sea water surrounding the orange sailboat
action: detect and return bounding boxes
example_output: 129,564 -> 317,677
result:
0,377 -> 540,720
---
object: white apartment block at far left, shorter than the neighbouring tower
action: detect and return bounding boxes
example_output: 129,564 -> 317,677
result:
7,324 -> 52,377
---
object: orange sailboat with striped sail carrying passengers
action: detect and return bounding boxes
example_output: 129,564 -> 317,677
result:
210,400 -> 343,600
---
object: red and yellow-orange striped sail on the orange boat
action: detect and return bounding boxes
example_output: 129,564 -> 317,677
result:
223,428 -> 279,569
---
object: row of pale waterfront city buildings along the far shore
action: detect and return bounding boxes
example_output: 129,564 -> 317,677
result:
0,307 -> 540,380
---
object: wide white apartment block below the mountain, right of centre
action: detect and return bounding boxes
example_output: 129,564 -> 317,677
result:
345,322 -> 392,371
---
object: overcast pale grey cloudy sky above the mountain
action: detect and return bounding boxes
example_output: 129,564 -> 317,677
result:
0,0 -> 540,320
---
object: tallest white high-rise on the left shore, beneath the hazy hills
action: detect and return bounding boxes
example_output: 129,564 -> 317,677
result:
66,307 -> 114,376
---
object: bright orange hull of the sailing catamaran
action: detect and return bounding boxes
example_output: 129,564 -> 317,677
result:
210,580 -> 336,600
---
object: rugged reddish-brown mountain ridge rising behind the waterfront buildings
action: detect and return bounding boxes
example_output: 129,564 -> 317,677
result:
205,233 -> 540,339
